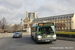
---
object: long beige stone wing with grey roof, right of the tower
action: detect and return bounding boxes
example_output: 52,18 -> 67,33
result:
33,14 -> 75,30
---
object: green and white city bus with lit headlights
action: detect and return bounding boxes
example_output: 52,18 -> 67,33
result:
31,22 -> 56,43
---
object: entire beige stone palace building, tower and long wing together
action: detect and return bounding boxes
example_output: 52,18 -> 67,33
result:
23,12 -> 75,30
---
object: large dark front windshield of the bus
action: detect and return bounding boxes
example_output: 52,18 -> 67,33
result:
39,26 -> 55,34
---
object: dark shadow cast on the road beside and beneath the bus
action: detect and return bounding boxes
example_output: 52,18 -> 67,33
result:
14,36 -> 54,45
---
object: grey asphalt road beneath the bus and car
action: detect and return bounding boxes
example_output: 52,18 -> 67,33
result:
0,36 -> 75,50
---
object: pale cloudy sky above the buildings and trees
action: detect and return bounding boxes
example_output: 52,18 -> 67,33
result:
0,0 -> 75,24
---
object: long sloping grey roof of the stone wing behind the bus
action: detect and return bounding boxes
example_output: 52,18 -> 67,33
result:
33,13 -> 74,22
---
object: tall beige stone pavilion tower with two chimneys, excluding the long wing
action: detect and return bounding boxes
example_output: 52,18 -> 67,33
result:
23,11 -> 37,30
